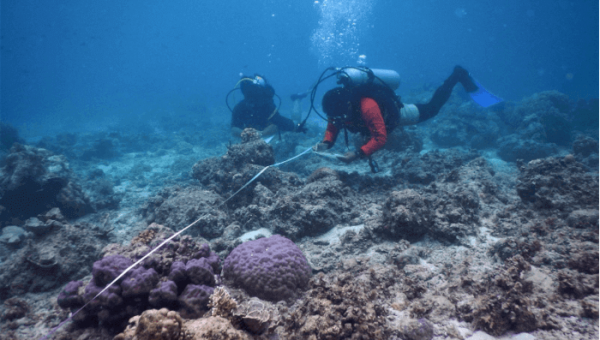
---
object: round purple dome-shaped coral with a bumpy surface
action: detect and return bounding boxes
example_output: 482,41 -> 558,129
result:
223,235 -> 312,301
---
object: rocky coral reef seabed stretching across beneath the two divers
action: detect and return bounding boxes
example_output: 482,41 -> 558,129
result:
0,89 -> 600,340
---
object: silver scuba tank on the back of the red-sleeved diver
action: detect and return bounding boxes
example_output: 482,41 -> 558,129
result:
337,67 -> 400,90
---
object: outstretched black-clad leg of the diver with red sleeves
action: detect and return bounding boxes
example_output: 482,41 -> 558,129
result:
416,66 -> 477,123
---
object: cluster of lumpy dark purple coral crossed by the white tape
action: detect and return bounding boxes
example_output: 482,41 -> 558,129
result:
58,224 -> 220,330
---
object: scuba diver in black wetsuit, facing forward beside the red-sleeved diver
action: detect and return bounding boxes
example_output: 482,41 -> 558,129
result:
227,75 -> 304,137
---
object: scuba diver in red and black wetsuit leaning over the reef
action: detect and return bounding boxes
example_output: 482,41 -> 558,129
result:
313,66 -> 480,163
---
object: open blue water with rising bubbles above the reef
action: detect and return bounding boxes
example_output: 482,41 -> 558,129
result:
0,0 -> 600,138
